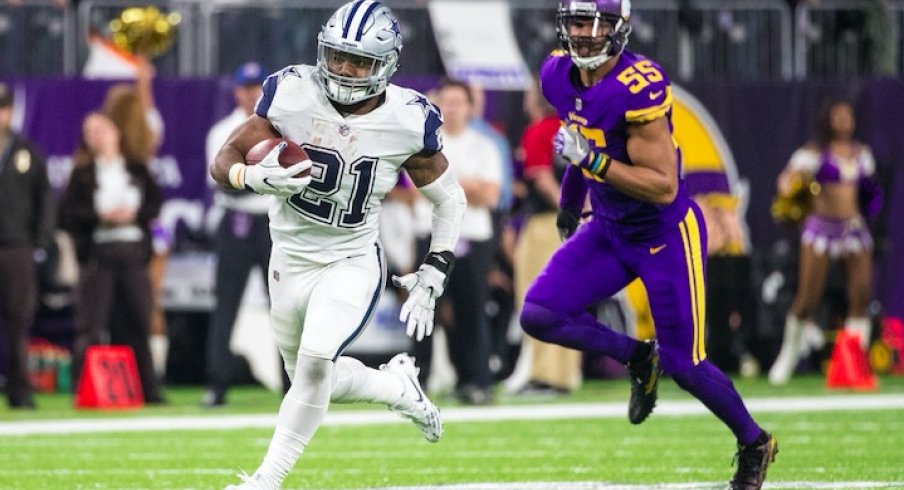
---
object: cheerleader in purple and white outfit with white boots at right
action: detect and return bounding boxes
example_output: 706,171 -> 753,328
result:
769,101 -> 881,384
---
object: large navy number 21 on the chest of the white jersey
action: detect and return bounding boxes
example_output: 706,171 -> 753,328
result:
289,145 -> 378,228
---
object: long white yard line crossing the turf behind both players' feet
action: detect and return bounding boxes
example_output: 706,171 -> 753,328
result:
0,395 -> 904,436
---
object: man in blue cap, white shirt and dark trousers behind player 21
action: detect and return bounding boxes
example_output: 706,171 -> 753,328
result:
201,62 -> 272,407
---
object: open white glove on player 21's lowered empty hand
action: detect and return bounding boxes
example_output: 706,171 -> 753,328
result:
392,264 -> 446,342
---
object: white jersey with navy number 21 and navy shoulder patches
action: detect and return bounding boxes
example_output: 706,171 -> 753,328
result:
255,65 -> 442,264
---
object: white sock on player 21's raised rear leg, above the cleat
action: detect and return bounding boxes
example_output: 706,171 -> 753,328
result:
331,356 -> 405,406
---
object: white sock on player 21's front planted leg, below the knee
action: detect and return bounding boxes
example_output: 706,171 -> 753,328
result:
255,354 -> 333,486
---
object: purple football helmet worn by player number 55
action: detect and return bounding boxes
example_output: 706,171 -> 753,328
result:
557,0 -> 631,70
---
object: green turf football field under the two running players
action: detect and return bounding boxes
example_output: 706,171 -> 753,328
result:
0,377 -> 904,490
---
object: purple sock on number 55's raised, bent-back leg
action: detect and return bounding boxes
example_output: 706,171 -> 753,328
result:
521,301 -> 639,364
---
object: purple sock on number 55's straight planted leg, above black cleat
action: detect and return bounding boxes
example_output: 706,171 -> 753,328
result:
669,361 -> 761,445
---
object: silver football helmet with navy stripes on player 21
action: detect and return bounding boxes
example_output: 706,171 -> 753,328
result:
317,0 -> 402,105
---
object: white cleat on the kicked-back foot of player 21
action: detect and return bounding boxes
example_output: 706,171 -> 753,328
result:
380,353 -> 443,442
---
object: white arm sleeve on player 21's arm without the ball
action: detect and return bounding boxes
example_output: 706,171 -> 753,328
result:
418,168 -> 468,253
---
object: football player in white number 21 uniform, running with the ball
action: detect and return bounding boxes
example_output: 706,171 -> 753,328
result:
210,0 -> 466,488
